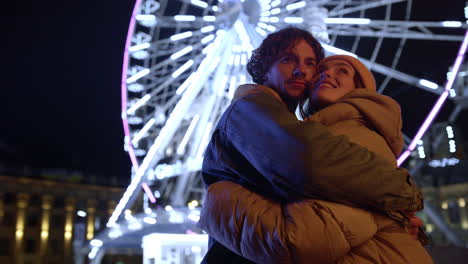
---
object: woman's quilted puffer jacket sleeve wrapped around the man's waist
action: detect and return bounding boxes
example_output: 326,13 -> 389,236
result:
199,181 -> 360,263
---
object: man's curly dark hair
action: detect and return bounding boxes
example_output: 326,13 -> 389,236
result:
247,27 -> 325,84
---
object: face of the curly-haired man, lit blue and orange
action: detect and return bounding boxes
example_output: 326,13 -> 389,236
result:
264,40 -> 317,102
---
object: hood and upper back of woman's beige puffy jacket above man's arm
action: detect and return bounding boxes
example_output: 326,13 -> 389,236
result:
305,89 -> 403,166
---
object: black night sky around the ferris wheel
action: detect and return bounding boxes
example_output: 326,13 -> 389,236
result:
0,0 -> 467,184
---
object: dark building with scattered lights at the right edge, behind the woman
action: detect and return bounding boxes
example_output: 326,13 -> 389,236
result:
409,118 -> 468,246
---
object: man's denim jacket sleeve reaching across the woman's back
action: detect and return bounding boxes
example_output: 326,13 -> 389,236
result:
219,93 -> 422,211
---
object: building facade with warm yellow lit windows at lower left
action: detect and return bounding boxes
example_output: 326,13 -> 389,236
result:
0,175 -> 124,264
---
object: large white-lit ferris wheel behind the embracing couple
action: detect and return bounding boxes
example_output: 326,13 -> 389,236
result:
87,0 -> 467,260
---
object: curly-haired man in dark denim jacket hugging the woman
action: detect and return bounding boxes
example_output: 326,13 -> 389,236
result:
202,27 -> 422,263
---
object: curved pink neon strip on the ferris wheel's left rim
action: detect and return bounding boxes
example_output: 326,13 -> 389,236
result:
120,0 -> 141,170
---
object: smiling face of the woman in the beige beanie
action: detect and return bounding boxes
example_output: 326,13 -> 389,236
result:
310,60 -> 356,107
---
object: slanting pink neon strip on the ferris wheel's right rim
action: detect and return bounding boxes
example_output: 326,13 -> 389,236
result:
397,30 -> 468,166
